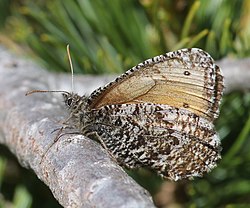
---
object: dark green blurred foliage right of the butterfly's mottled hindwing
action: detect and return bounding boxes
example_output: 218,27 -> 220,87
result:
188,92 -> 250,207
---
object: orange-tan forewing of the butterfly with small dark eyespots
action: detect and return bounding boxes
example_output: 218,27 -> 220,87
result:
89,49 -> 223,121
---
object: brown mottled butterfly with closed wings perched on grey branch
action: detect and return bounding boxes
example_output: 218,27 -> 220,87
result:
59,48 -> 224,181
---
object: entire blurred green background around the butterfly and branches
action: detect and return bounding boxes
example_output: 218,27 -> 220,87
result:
0,0 -> 250,208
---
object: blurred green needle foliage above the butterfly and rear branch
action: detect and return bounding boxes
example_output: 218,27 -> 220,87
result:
2,0 -> 250,73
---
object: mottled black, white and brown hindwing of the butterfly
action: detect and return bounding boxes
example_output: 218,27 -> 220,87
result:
86,104 -> 220,180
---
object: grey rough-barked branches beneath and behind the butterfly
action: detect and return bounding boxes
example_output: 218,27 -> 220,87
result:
0,47 -> 250,208
